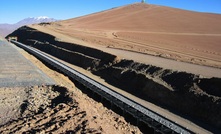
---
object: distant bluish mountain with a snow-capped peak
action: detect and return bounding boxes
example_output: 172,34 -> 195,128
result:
0,16 -> 57,37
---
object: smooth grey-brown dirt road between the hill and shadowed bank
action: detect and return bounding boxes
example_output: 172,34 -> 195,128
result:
101,48 -> 221,78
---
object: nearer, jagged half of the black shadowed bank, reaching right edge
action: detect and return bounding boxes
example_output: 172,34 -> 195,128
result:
94,60 -> 221,127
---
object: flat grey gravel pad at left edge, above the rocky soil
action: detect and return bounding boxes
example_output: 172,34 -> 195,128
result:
0,41 -> 54,87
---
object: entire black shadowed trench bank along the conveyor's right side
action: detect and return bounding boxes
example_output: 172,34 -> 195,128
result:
6,26 -> 221,131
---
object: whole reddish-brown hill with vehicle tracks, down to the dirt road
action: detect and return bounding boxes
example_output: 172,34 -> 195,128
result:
36,3 -> 221,68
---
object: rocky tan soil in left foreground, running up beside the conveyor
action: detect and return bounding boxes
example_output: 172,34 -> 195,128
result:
0,45 -> 141,134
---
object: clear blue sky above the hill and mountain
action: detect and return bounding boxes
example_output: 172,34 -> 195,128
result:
0,0 -> 221,24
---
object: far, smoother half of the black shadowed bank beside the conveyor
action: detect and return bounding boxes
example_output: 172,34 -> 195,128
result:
9,27 -> 116,70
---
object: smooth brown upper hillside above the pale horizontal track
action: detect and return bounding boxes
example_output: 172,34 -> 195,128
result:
61,3 -> 221,34
